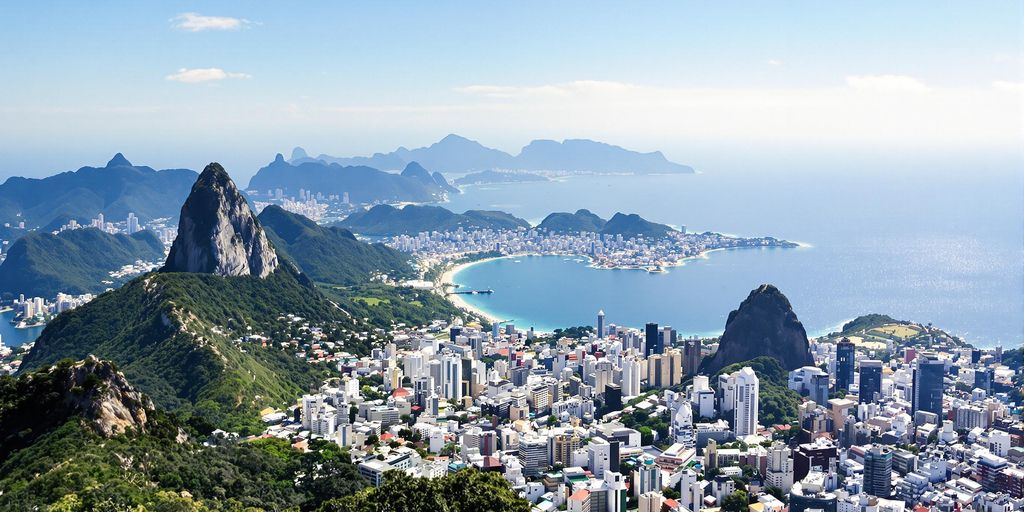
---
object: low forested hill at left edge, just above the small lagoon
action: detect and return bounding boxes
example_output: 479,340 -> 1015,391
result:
0,227 -> 164,298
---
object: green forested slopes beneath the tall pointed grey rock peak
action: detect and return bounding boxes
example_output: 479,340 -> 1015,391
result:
24,267 -> 360,432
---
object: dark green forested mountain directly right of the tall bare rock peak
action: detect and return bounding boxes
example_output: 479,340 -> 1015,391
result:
258,205 -> 414,286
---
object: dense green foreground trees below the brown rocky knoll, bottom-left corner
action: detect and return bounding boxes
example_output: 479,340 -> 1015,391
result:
0,416 -> 366,512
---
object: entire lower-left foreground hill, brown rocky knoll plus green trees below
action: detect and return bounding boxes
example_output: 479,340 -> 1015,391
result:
0,357 -> 367,512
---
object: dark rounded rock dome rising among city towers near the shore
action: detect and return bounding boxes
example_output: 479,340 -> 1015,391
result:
700,285 -> 814,375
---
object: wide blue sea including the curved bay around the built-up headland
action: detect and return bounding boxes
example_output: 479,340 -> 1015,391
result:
442,157 -> 1024,347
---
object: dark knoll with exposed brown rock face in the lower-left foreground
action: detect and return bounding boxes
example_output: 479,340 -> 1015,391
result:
0,357 -> 154,460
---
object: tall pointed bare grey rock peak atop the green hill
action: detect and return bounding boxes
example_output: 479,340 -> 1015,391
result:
163,163 -> 279,278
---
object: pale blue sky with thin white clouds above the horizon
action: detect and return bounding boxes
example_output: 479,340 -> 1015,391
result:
0,1 -> 1024,178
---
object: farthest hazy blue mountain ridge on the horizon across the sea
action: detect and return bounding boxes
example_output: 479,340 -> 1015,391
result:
292,133 -> 694,174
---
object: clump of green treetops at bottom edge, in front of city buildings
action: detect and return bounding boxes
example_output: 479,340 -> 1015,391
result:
318,469 -> 530,512
